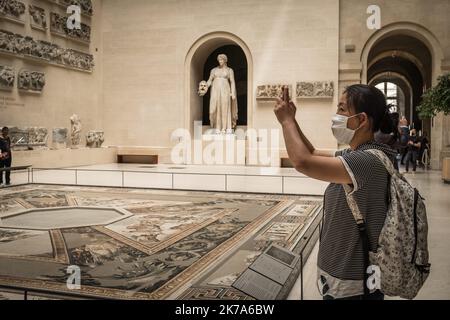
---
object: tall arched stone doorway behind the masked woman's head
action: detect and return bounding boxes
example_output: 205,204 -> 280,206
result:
361,22 -> 444,169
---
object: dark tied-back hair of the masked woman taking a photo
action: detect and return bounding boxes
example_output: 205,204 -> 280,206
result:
344,84 -> 394,133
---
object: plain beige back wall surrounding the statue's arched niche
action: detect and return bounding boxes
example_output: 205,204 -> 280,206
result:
101,0 -> 339,149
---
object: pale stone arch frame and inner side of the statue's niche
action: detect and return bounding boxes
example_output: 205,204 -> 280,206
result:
184,32 -> 253,133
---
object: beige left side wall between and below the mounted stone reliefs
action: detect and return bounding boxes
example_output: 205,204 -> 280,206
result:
0,0 -> 102,151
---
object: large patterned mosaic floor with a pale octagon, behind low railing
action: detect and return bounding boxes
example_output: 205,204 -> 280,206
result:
0,185 -> 322,299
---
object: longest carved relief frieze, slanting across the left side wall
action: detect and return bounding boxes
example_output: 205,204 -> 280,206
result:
0,30 -> 94,72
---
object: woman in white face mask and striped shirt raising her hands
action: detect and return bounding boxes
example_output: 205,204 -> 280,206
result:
274,85 -> 395,300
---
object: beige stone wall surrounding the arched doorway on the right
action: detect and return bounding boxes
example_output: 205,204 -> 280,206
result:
339,0 -> 450,169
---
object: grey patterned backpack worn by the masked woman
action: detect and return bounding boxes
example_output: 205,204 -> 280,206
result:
344,150 -> 430,299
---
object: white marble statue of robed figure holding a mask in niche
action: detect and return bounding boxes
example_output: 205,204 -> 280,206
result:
199,54 -> 238,134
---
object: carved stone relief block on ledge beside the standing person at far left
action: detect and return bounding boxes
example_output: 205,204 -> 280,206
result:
9,127 -> 48,150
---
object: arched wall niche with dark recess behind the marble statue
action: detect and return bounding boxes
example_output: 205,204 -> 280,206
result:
184,32 -> 253,133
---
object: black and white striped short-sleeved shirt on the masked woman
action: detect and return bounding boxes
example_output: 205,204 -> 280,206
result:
318,142 -> 395,282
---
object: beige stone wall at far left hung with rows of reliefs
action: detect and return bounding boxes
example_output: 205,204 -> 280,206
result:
0,0 -> 102,152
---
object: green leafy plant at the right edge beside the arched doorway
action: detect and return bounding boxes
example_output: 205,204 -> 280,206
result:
417,73 -> 450,119
